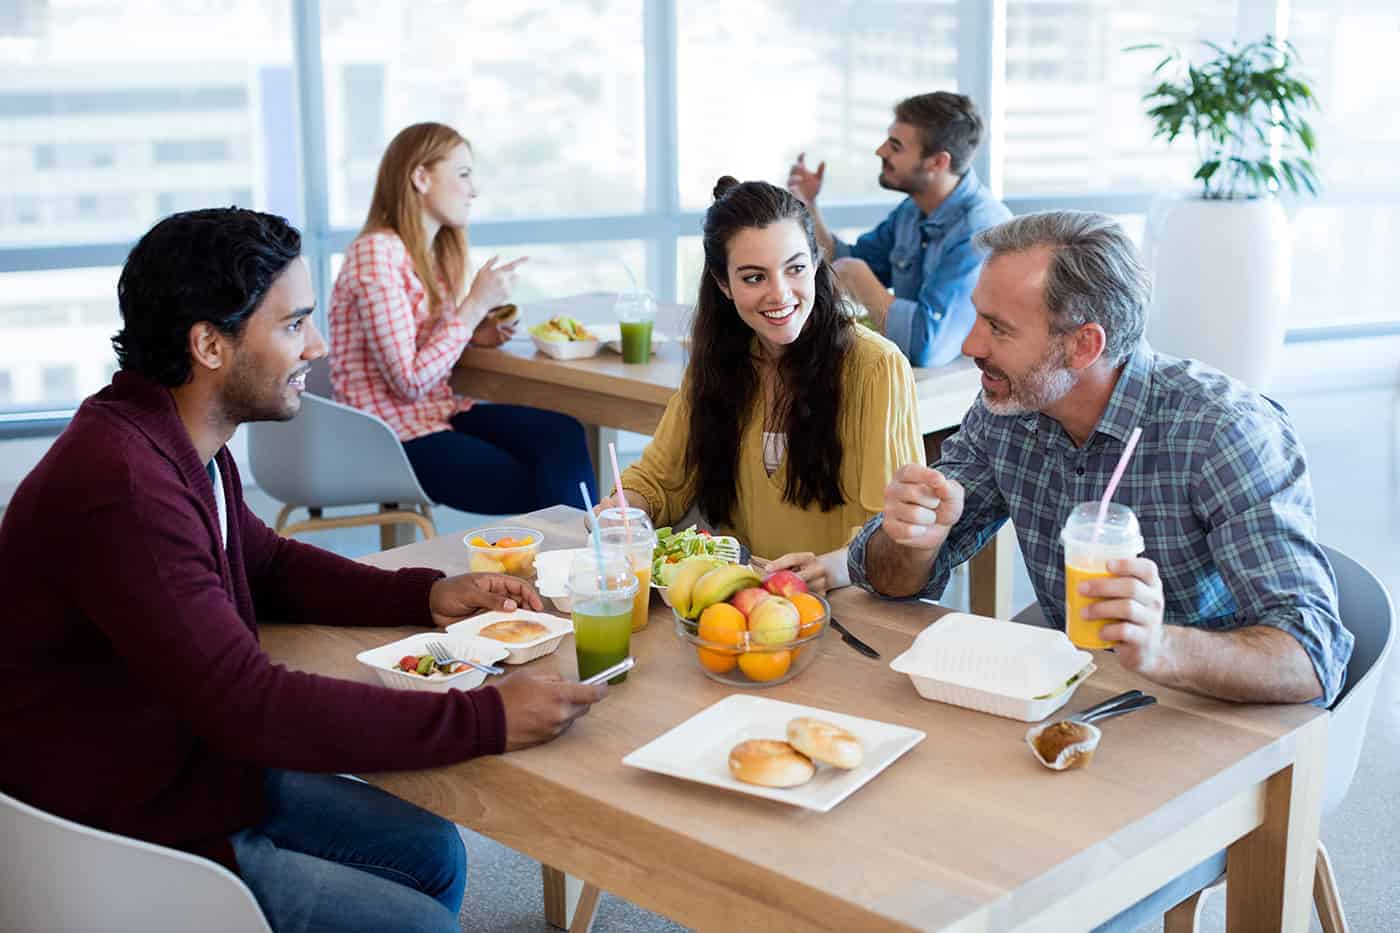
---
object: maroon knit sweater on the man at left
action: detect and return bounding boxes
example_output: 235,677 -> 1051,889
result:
0,373 -> 505,867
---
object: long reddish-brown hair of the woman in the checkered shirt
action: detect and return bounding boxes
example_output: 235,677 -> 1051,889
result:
360,123 -> 472,315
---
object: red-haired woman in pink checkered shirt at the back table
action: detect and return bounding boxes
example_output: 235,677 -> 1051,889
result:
329,123 -> 594,514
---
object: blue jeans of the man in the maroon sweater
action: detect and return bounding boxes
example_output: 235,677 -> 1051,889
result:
231,770 -> 466,933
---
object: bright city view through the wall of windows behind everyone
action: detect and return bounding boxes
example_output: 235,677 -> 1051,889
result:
0,0 -> 1400,413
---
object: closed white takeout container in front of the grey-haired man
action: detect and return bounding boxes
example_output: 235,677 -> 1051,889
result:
889,612 -> 1095,723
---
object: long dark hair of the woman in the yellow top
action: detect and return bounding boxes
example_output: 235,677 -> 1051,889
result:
686,175 -> 855,524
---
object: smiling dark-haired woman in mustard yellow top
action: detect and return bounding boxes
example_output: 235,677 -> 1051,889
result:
605,177 -> 924,591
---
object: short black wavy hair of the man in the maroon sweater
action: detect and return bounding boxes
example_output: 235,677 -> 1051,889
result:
112,207 -> 301,388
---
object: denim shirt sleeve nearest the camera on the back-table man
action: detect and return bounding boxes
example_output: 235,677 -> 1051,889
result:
885,231 -> 983,366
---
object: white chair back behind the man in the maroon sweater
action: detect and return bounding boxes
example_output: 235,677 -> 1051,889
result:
0,793 -> 272,933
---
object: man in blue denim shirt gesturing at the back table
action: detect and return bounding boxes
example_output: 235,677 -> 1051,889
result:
788,91 -> 1011,366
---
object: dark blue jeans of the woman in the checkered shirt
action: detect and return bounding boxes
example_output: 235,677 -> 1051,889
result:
403,402 -> 598,516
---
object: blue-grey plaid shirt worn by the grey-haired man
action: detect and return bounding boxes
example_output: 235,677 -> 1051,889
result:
848,343 -> 1352,705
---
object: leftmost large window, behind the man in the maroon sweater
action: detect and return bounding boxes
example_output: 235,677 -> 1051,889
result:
0,0 -> 301,409
